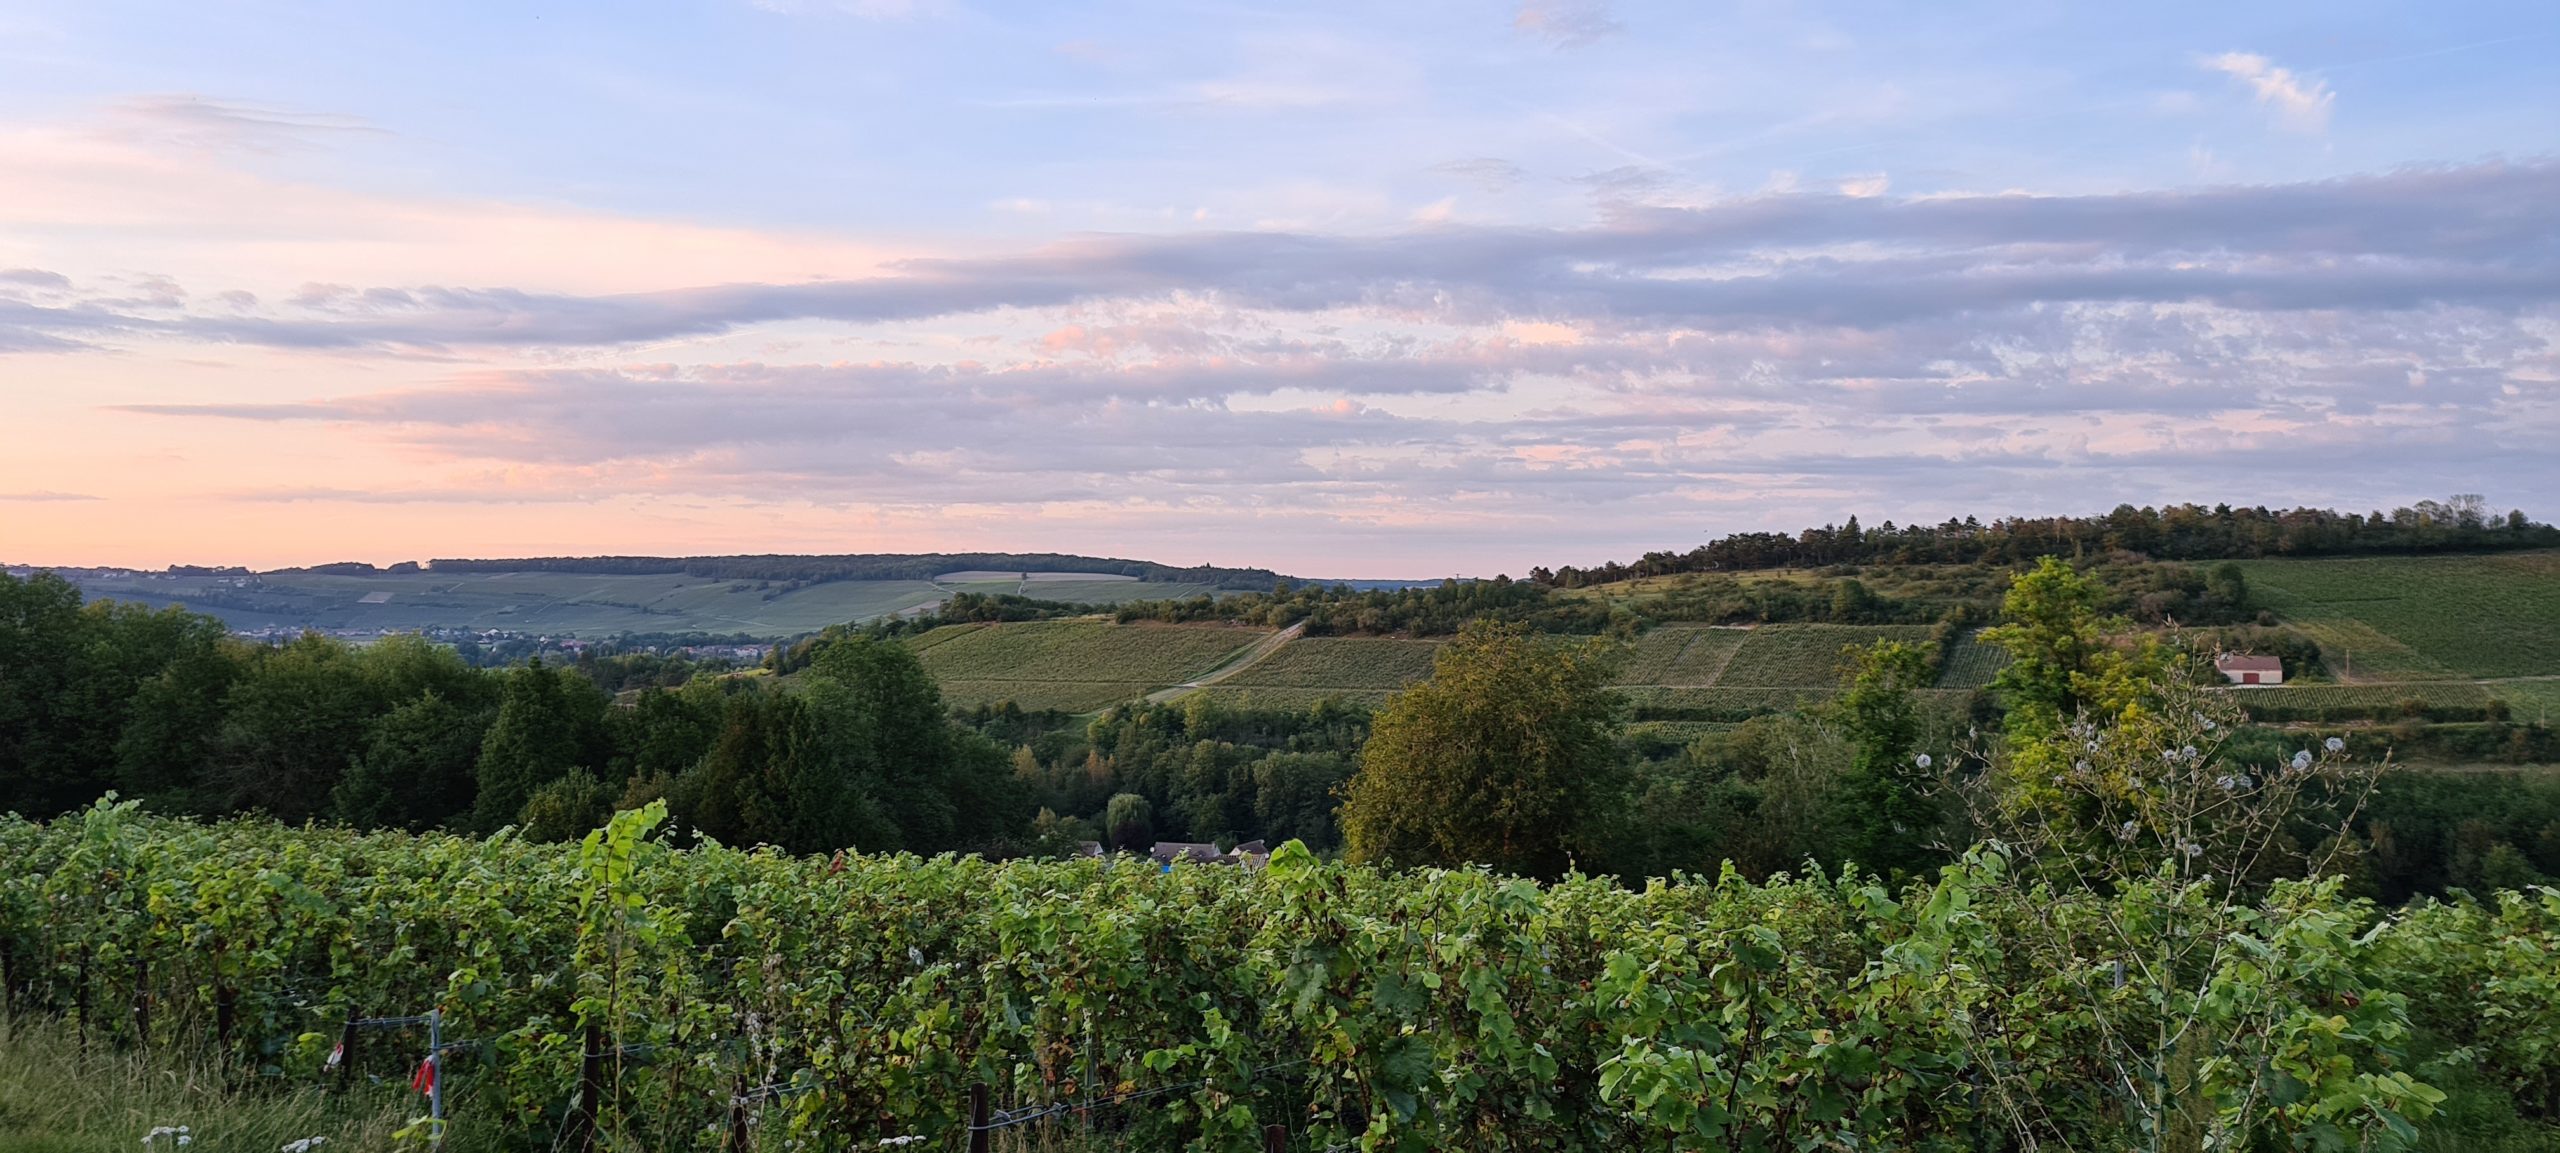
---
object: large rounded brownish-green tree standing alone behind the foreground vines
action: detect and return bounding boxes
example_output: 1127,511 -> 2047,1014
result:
1341,620 -> 1623,876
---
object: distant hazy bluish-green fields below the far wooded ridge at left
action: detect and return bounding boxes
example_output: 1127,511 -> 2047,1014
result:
57,571 -> 1213,638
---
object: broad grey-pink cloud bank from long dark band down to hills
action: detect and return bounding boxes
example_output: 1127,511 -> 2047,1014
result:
20,161 -> 2560,561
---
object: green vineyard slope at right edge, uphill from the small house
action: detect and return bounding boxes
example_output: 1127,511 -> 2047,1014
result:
2240,551 -> 2560,682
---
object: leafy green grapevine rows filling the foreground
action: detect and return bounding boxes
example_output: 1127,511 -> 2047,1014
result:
0,805 -> 2560,1150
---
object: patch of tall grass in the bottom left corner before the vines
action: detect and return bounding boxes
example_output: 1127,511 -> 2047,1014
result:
0,1017 -> 435,1153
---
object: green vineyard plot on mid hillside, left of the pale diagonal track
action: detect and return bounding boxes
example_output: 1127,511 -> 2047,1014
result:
909,620 -> 1270,712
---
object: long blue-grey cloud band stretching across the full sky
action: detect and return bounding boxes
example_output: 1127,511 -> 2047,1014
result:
0,161 -> 2560,351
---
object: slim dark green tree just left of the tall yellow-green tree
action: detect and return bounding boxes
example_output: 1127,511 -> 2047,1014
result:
1830,641 -> 1940,876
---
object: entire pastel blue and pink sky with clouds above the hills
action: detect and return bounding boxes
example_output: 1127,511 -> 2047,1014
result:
0,0 -> 2560,579
